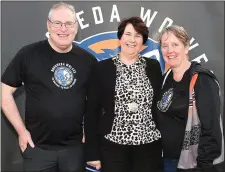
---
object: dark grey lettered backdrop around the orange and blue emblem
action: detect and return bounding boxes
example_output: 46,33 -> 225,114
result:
1,1 -> 224,171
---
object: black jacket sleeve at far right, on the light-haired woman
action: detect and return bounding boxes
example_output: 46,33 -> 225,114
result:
195,73 -> 222,168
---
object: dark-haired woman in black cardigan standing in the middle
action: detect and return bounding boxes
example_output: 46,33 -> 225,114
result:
84,17 -> 162,172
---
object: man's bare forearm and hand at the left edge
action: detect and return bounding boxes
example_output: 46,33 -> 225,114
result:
2,83 -> 34,152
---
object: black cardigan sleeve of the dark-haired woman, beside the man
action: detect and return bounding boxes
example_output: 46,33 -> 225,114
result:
84,61 -> 100,161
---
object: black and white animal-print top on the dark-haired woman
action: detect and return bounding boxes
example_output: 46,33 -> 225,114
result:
105,55 -> 161,145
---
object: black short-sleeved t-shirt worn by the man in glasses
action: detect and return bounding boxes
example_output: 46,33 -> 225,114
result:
2,40 -> 96,149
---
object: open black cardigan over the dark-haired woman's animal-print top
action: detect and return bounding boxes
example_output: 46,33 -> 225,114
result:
84,58 -> 162,161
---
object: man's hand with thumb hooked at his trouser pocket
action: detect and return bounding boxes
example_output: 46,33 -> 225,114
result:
19,130 -> 34,152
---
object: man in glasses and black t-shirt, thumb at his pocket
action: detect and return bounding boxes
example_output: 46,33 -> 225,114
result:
2,2 -> 96,172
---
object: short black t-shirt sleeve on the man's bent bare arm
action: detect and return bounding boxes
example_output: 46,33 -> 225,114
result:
1,48 -> 27,87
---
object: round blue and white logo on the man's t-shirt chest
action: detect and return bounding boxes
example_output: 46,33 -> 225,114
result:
51,63 -> 76,89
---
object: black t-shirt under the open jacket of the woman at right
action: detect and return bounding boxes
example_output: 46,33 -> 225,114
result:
156,69 -> 191,159
